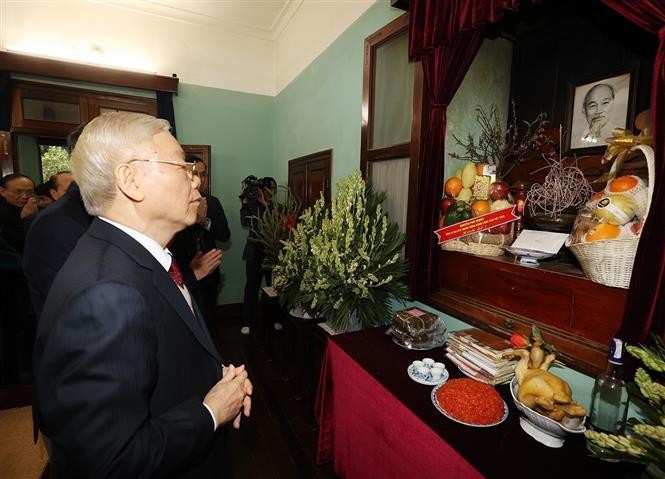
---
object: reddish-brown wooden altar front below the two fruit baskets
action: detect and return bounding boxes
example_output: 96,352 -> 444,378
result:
430,251 -> 627,374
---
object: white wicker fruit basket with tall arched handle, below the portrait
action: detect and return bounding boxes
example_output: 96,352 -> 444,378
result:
568,133 -> 655,289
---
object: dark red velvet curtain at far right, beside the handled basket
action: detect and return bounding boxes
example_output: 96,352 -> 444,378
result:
603,0 -> 665,343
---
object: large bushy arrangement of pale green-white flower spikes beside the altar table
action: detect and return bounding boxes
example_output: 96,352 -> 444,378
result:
273,170 -> 407,331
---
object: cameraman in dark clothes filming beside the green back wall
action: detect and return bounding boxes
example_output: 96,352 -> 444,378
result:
240,176 -> 277,334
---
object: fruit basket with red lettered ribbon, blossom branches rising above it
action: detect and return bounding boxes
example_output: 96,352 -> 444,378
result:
439,102 -> 551,256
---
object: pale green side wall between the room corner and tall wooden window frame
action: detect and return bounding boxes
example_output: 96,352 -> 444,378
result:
273,2 -> 404,189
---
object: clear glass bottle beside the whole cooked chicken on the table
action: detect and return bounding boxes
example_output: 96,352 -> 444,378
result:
589,338 -> 628,434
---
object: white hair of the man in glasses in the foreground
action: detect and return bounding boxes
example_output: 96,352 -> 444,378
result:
70,112 -> 170,216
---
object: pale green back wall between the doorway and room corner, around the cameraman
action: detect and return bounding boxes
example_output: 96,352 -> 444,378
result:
173,83 -> 274,304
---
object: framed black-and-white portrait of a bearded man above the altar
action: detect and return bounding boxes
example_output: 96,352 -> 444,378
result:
565,70 -> 637,154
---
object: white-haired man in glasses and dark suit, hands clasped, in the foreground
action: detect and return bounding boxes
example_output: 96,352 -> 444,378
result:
34,113 -> 252,479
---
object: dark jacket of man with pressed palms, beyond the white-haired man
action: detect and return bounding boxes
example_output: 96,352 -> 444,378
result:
170,195 -> 231,290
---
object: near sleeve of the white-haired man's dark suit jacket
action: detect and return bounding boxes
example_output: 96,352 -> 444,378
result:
37,282 -> 214,479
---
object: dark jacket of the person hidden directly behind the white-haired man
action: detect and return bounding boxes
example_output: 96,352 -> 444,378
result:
23,182 -> 92,318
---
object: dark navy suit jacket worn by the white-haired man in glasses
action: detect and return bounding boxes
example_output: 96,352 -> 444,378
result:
34,219 -> 223,479
